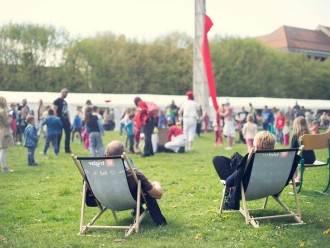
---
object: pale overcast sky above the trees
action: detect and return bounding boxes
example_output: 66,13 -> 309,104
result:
0,0 -> 330,41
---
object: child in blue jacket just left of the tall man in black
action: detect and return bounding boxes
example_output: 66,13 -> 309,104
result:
42,109 -> 62,156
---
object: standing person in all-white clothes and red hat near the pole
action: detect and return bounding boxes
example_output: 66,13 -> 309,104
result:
179,91 -> 199,150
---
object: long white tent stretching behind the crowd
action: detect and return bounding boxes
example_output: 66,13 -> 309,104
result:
0,91 -> 330,129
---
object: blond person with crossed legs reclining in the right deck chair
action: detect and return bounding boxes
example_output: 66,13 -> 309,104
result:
213,131 -> 275,210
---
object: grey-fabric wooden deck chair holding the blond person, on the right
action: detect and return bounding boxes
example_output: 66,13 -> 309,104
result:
219,149 -> 303,228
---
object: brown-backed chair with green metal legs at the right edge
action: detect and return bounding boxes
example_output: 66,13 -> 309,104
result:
297,133 -> 330,194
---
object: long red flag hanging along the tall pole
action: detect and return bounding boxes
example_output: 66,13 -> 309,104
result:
201,15 -> 222,144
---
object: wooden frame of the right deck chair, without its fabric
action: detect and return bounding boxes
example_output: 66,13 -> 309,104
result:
219,149 -> 303,228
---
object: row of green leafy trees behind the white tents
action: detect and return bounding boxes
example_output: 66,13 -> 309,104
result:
0,23 -> 330,99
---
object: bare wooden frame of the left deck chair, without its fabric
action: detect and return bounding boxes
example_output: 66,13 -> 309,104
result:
71,153 -> 148,237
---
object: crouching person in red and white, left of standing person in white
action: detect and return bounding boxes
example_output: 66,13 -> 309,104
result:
165,120 -> 188,153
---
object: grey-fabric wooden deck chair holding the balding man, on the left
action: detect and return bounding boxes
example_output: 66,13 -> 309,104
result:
71,154 -> 148,236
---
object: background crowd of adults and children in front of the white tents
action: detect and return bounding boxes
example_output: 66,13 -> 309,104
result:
1,88 -> 330,170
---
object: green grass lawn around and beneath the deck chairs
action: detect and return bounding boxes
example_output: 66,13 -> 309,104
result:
0,132 -> 330,247
